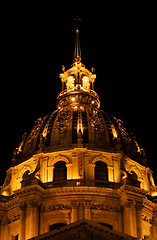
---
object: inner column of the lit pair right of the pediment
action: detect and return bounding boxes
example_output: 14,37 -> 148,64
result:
123,200 -> 133,236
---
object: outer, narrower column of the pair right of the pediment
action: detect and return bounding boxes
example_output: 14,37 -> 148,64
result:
135,202 -> 143,239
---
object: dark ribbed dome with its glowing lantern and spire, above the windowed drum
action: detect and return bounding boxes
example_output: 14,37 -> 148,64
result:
13,30 -> 146,165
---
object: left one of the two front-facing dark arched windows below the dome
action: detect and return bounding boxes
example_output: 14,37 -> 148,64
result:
54,161 -> 67,181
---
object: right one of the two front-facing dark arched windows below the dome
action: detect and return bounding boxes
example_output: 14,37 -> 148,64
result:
95,161 -> 108,181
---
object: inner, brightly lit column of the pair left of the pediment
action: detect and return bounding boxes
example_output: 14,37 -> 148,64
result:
26,199 -> 40,239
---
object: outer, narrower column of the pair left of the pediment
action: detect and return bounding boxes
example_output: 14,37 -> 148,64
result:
19,202 -> 26,240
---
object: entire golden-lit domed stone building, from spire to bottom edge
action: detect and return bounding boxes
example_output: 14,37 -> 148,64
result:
0,29 -> 157,240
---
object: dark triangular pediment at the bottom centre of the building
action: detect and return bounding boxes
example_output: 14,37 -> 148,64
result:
28,219 -> 137,240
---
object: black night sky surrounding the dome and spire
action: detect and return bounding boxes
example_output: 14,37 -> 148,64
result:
0,5 -> 157,185
